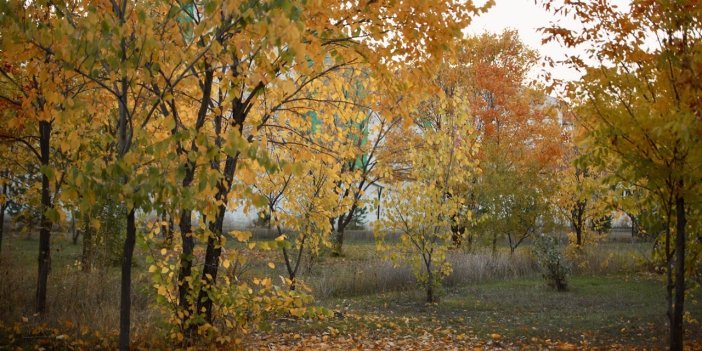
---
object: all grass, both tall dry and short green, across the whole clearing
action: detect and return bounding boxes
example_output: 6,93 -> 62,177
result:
0,234 -> 702,348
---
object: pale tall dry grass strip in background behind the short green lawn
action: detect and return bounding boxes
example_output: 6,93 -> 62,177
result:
302,242 -> 650,299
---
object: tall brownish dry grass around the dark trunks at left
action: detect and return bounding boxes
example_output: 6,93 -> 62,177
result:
0,239 -> 164,339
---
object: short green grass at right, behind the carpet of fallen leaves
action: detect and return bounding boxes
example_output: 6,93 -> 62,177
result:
282,274 -> 702,348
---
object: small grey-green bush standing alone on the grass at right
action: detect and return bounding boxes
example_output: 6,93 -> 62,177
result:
532,236 -> 570,291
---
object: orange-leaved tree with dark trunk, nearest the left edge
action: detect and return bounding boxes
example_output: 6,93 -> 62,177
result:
0,10 -> 86,313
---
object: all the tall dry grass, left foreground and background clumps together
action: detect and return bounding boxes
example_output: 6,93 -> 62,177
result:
0,236 -> 650,348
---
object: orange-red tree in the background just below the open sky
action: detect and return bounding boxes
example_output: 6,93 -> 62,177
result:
448,31 -> 565,252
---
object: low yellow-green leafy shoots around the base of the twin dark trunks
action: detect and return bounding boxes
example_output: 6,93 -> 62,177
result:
143,222 -> 326,345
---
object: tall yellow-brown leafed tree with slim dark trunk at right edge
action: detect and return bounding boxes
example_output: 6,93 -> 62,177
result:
542,1 -> 702,350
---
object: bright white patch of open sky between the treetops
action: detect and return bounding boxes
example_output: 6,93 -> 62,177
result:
466,0 -> 579,83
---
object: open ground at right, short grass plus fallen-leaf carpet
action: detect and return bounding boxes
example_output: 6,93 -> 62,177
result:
262,274 -> 702,350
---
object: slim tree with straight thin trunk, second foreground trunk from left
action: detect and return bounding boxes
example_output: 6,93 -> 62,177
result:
5,2 -> 206,350
